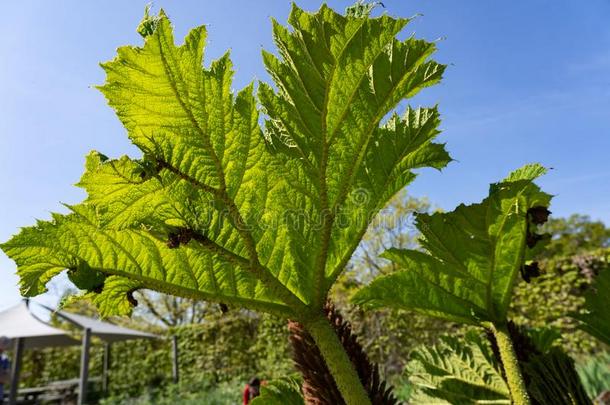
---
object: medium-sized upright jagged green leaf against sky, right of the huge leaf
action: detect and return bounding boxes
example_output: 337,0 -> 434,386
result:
354,165 -> 551,324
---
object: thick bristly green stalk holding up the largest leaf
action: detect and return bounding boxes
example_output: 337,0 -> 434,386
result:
304,315 -> 371,405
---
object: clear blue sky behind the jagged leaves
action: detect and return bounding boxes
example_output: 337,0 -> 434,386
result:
0,0 -> 610,309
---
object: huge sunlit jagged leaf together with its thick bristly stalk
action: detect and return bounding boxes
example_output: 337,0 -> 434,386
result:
2,6 -> 450,404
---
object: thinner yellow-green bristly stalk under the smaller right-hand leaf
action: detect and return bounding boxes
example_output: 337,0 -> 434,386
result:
492,325 -> 530,405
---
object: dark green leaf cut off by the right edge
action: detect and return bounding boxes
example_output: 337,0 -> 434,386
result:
572,261 -> 610,345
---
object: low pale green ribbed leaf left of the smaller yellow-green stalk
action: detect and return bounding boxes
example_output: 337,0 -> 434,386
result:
407,335 -> 511,405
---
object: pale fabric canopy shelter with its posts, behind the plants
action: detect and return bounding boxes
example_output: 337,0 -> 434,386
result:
0,299 -> 164,405
